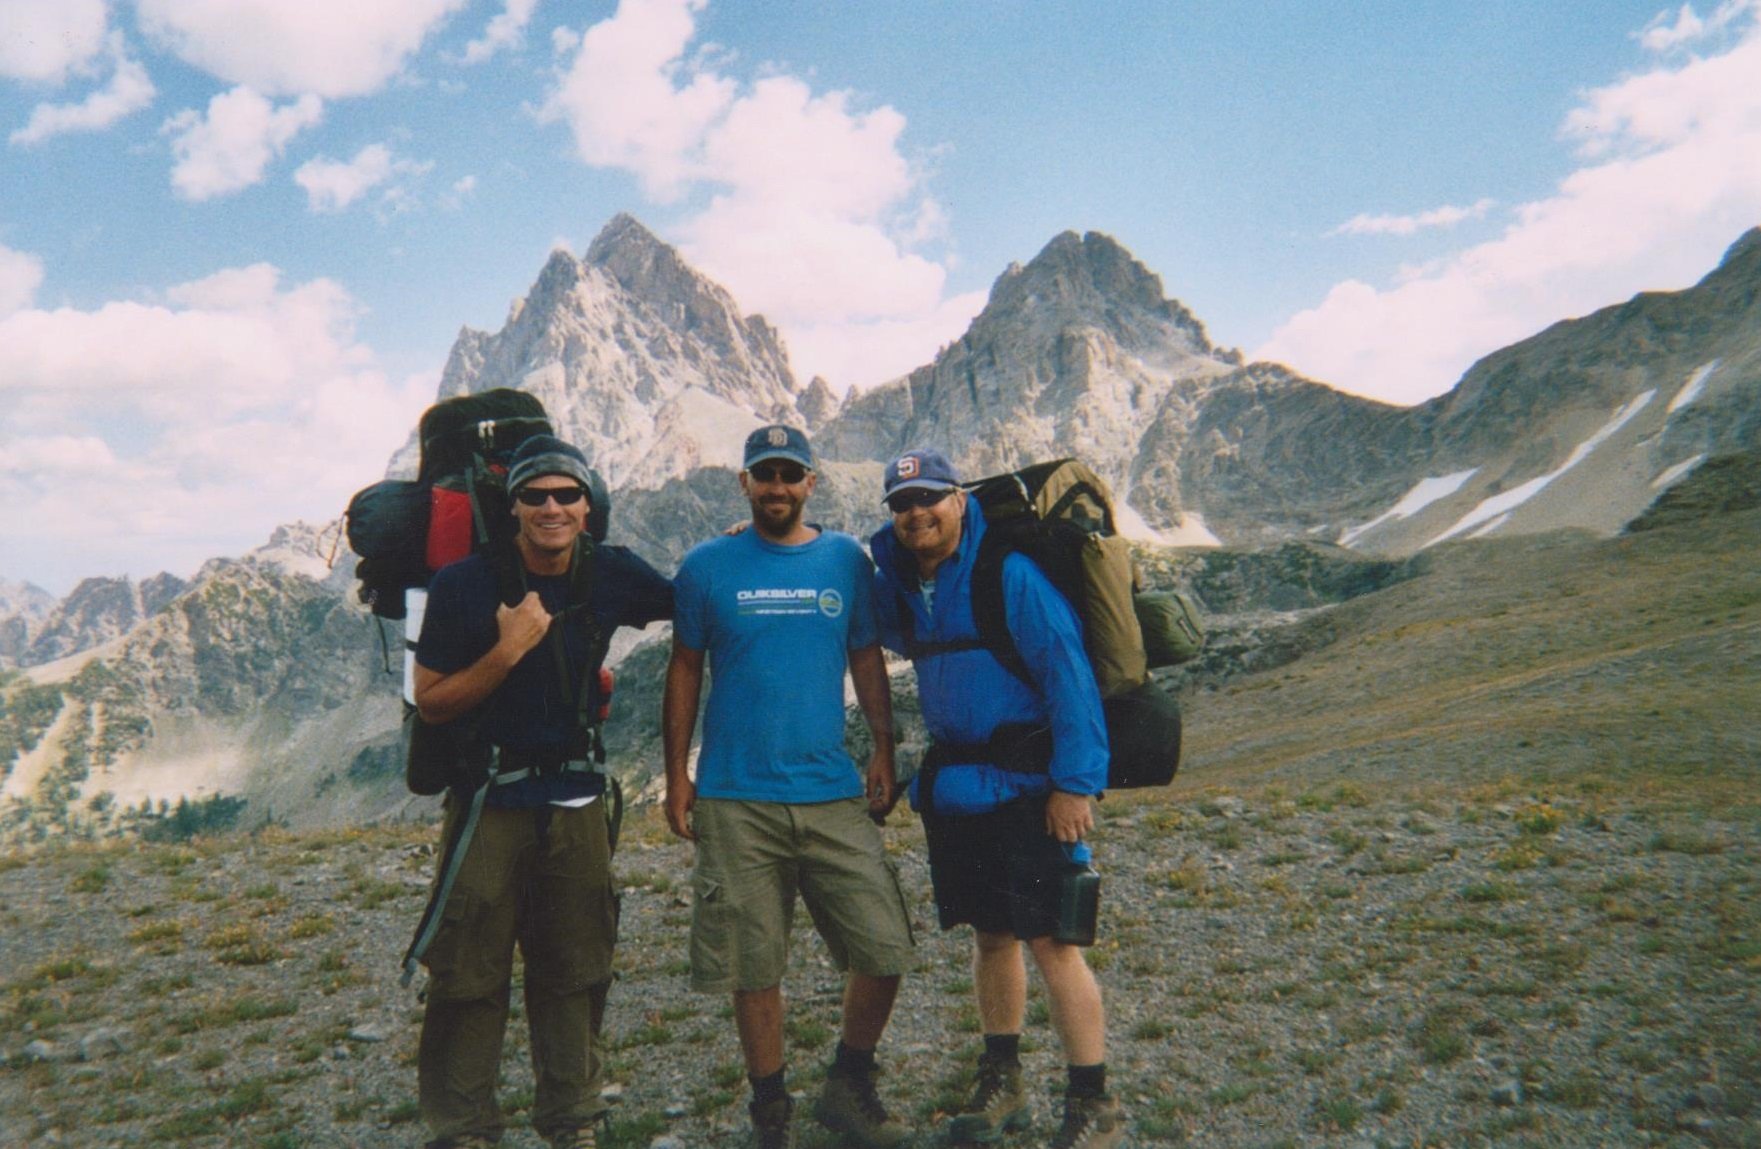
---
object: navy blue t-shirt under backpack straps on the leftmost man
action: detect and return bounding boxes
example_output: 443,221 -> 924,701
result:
416,545 -> 673,807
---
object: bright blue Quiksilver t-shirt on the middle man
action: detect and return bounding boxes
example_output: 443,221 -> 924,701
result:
673,529 -> 877,804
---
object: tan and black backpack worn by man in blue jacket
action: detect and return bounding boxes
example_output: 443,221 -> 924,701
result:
900,458 -> 1203,789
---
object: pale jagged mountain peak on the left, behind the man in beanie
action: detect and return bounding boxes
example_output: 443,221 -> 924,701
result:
391,215 -> 799,488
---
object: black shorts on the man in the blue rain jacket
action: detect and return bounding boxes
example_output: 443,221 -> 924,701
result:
925,795 -> 1071,941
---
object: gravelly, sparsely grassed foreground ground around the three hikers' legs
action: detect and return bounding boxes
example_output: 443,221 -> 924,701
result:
0,782 -> 1761,1149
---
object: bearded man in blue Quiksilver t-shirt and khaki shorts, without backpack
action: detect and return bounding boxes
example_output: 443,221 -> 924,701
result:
662,426 -> 912,1149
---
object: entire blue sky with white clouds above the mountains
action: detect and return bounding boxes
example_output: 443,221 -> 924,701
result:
0,0 -> 1761,592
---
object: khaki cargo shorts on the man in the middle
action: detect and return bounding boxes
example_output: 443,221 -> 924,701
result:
690,798 -> 916,994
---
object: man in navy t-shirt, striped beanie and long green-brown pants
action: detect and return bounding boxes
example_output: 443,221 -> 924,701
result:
416,435 -> 673,1149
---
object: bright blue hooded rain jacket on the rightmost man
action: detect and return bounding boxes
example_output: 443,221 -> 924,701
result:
870,499 -> 1108,814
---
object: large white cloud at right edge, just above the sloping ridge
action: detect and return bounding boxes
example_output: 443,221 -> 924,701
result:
1254,9 -> 1761,404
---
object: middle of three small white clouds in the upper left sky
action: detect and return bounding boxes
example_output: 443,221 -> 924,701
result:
160,88 -> 324,199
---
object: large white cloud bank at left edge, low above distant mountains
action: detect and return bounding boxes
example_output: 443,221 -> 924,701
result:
0,264 -> 435,589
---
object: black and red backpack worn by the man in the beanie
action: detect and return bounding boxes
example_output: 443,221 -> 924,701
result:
347,388 -> 611,620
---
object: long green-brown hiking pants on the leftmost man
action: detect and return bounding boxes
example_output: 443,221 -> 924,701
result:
417,798 -> 618,1138
